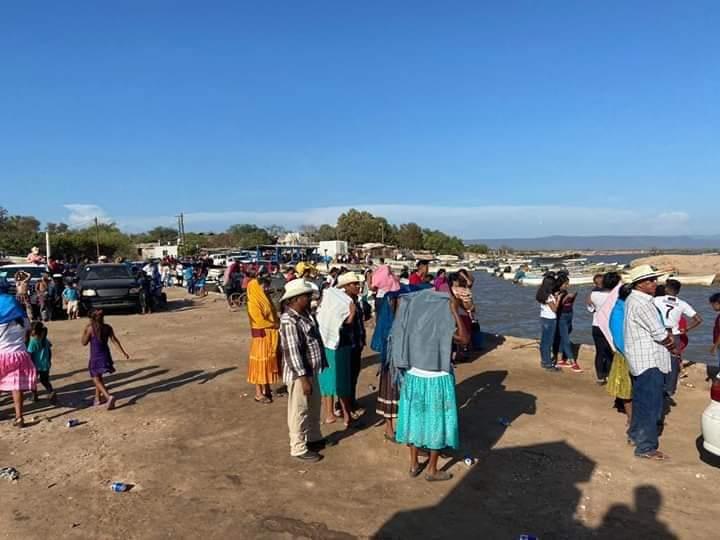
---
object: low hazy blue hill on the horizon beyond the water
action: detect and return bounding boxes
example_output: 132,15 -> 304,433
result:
465,235 -> 720,251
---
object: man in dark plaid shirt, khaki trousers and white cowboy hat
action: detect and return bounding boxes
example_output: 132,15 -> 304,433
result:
280,279 -> 327,463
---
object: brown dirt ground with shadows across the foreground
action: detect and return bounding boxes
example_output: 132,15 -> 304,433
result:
0,291 -> 720,540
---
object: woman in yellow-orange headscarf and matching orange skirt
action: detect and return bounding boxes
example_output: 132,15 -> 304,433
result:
247,273 -> 280,404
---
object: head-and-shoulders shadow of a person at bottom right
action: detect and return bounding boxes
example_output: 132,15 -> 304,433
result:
595,485 -> 678,540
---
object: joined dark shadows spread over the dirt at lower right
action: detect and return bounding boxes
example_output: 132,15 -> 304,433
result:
373,371 -> 677,540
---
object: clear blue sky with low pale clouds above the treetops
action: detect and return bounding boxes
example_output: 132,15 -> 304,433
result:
0,0 -> 720,238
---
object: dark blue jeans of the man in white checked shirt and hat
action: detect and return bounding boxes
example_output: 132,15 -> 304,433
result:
628,368 -> 665,455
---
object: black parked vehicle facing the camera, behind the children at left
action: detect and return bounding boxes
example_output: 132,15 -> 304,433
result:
78,264 -> 141,312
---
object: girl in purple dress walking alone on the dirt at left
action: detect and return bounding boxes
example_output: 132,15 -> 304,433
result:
82,309 -> 130,410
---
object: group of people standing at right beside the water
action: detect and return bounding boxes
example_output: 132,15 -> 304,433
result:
536,265 -> 720,460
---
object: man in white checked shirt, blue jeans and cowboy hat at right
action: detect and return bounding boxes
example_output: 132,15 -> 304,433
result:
625,264 -> 675,460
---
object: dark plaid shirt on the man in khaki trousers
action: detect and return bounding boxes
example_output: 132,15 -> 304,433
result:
280,308 -> 327,385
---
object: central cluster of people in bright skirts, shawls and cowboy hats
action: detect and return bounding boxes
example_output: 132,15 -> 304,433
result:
239,260 -> 477,481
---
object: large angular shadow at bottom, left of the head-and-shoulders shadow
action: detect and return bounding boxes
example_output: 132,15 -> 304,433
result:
372,441 -> 592,540
